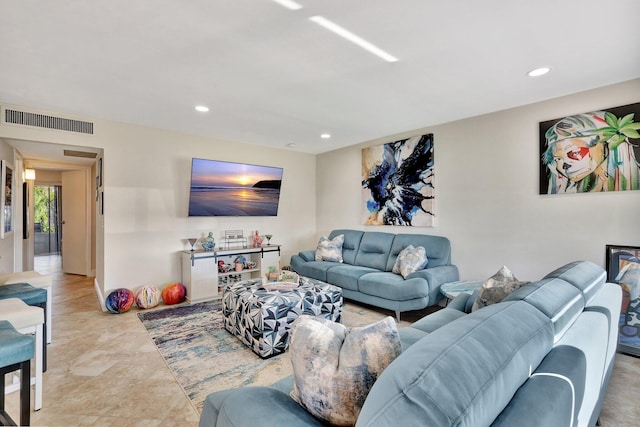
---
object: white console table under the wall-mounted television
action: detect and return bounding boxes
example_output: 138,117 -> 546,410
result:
180,245 -> 280,302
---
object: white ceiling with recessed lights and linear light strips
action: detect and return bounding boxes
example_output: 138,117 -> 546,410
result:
0,0 -> 640,157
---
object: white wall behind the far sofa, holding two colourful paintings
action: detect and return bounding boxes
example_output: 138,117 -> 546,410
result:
316,80 -> 640,280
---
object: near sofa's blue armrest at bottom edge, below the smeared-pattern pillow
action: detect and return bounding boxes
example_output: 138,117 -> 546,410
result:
199,387 -> 323,427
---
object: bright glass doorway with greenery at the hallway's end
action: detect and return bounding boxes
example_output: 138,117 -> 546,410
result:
33,185 -> 62,256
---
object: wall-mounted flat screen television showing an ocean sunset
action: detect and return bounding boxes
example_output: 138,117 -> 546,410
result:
189,158 -> 282,216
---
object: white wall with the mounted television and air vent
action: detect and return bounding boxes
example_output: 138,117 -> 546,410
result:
0,107 -> 316,296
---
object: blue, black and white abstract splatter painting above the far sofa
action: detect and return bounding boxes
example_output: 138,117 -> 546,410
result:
362,133 -> 435,227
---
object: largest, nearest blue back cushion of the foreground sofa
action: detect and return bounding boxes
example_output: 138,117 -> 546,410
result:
356,301 -> 553,426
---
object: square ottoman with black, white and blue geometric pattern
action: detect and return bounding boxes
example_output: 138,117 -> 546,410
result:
222,277 -> 343,358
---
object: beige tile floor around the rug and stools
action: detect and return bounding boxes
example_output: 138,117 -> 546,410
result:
7,256 -> 640,427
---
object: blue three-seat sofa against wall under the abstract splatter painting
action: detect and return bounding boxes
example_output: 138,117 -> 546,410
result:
291,230 -> 458,320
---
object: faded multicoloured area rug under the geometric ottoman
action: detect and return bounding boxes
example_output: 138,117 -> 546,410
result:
138,300 -> 292,412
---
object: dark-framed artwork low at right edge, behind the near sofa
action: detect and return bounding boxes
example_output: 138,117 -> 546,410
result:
606,245 -> 640,356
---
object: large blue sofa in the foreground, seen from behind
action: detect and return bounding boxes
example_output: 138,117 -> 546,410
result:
200,261 -> 622,427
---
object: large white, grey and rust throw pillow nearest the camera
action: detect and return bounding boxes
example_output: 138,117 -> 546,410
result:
289,315 -> 401,426
